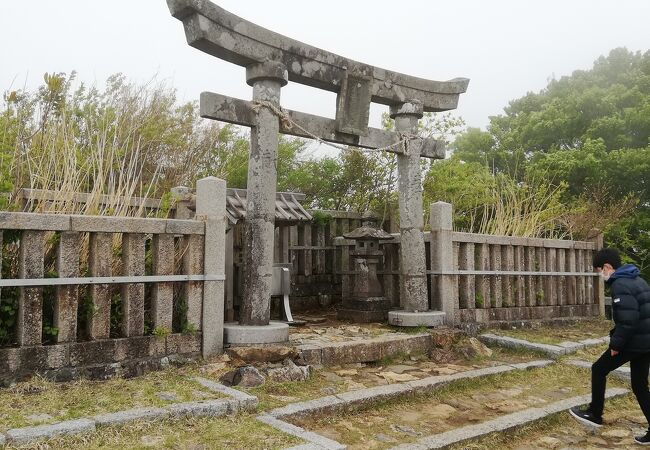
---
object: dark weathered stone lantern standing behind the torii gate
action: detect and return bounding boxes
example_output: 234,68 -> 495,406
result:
337,216 -> 393,322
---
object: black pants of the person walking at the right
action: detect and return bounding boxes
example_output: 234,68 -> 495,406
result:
591,349 -> 650,424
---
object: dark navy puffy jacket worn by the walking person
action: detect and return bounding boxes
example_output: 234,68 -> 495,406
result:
607,264 -> 650,353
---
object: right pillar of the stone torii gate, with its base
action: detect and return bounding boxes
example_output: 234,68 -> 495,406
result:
388,100 -> 439,326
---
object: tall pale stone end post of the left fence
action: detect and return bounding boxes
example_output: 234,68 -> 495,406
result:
196,177 -> 227,358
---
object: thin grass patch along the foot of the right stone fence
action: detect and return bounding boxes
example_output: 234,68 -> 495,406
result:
489,319 -> 612,344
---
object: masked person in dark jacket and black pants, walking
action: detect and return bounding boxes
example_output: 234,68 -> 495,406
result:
569,248 -> 650,445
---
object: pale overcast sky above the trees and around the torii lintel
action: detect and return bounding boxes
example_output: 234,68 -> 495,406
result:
0,0 -> 650,135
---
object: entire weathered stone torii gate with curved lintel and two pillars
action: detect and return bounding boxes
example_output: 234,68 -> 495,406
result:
167,0 -> 469,344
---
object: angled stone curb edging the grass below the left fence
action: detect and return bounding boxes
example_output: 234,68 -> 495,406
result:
0,377 -> 258,445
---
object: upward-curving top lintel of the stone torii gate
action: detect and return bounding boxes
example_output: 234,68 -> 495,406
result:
167,0 -> 469,134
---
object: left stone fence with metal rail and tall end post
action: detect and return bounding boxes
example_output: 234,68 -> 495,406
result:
0,177 -> 226,383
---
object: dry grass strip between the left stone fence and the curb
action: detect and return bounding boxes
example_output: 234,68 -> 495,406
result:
0,367 -> 222,430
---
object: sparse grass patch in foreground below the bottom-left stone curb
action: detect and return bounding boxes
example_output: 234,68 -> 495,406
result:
6,414 -> 301,450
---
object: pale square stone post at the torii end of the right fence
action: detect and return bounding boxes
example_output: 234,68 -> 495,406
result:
429,202 -> 458,326
